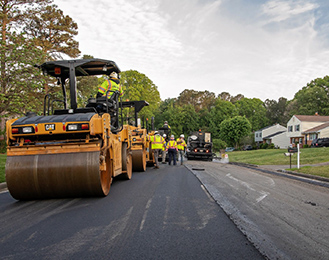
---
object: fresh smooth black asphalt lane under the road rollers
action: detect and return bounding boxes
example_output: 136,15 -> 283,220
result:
0,165 -> 262,260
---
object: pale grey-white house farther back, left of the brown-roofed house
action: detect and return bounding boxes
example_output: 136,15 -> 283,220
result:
255,124 -> 289,148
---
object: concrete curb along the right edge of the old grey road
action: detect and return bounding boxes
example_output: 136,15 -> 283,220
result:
229,162 -> 329,188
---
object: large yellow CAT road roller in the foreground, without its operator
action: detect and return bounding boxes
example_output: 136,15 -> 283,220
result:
5,59 -> 135,200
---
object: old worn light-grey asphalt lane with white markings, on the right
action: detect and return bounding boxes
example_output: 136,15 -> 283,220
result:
187,161 -> 329,260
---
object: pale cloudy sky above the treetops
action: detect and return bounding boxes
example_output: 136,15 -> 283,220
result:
54,0 -> 329,101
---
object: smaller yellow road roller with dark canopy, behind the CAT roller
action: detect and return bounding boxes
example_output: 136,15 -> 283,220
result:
121,101 -> 150,172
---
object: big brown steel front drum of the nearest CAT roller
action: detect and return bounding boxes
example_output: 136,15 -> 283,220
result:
6,151 -> 111,200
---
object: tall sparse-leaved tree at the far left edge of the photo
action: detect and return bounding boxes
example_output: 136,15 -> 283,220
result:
0,0 -> 51,117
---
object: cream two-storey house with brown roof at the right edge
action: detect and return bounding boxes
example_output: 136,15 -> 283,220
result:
287,115 -> 329,145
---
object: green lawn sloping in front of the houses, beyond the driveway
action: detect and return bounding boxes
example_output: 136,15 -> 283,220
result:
227,147 -> 329,165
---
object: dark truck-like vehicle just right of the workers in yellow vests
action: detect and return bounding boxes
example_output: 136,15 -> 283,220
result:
186,130 -> 213,161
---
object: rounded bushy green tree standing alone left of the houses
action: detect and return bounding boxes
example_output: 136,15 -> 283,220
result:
219,116 -> 251,148
